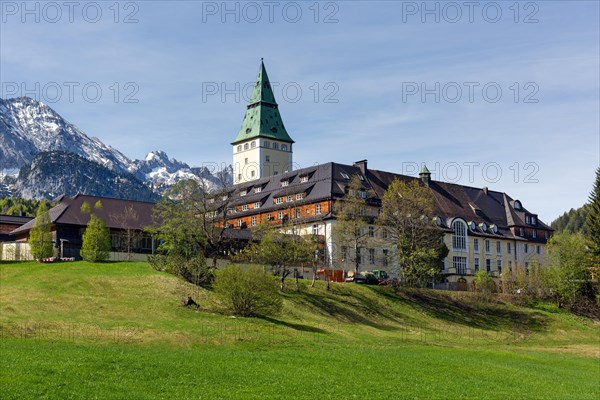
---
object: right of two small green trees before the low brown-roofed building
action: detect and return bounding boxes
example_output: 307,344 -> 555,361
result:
80,201 -> 110,262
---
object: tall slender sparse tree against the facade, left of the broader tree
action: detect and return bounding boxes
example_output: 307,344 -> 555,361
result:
333,175 -> 371,274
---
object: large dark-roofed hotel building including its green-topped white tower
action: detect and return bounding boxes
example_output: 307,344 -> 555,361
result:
229,62 -> 552,289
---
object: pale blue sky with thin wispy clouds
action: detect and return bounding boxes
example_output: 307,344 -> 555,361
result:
0,1 -> 600,222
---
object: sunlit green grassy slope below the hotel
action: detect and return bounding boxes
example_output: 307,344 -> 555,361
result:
0,262 -> 600,399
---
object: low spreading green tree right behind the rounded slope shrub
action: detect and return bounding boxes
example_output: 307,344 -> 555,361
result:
237,224 -> 317,292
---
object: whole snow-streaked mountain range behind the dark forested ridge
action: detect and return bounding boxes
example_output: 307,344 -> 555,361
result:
0,97 -> 233,198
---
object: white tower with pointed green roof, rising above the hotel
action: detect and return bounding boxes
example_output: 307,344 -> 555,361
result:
231,59 -> 294,184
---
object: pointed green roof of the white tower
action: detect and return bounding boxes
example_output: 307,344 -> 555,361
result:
231,59 -> 294,144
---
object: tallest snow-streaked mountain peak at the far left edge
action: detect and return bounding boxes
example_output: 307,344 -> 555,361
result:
0,97 -> 131,172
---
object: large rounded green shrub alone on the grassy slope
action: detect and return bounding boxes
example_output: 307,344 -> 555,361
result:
214,265 -> 283,317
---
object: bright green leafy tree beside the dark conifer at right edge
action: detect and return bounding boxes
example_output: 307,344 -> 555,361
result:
543,233 -> 591,307
